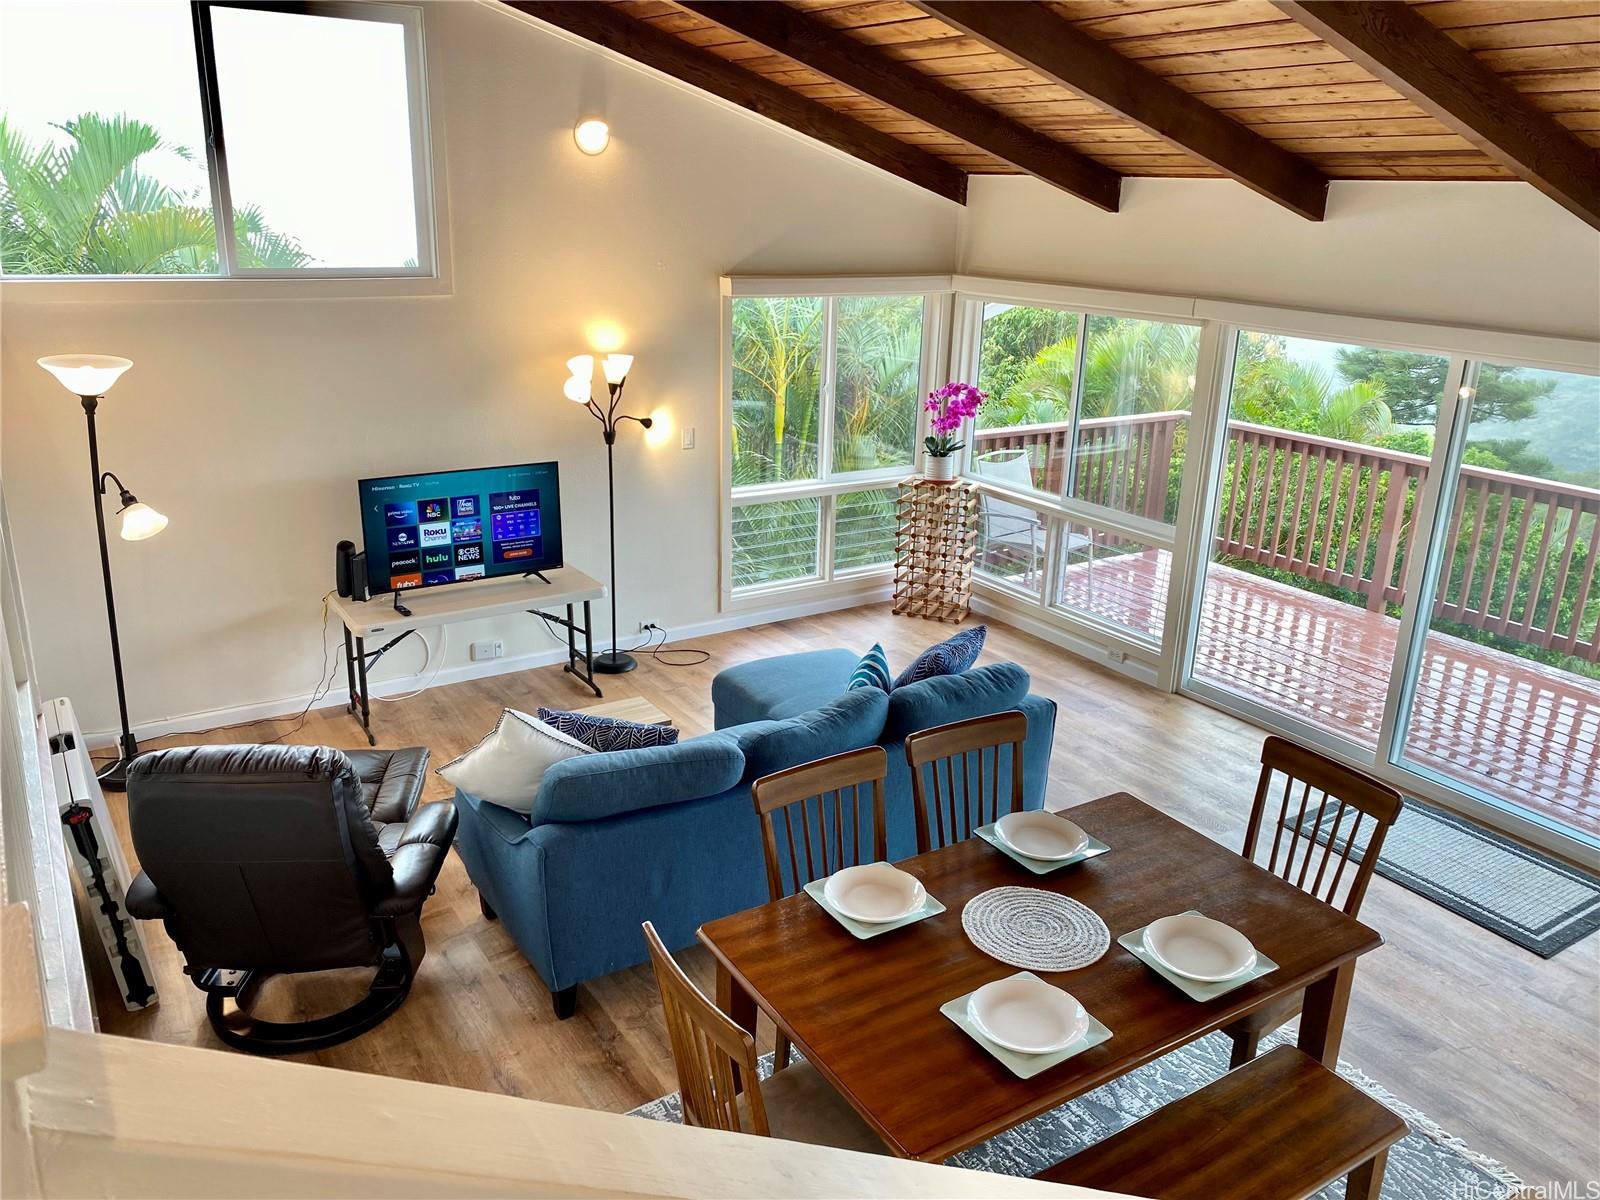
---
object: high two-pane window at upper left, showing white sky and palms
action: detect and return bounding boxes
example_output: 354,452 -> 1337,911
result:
0,0 -> 434,277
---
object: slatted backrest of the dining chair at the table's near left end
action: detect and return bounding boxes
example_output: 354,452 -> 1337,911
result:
643,922 -> 771,1136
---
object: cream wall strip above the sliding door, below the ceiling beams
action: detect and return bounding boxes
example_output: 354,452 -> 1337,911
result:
958,176 -> 1600,338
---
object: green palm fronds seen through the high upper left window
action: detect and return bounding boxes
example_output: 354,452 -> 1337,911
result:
0,112 -> 310,275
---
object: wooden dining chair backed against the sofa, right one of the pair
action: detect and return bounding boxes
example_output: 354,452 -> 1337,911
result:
906,712 -> 1027,854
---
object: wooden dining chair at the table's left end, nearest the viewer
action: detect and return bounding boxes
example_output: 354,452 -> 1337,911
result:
643,922 -> 888,1154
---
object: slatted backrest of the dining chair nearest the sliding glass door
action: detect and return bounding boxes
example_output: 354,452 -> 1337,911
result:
1245,738 -> 1403,917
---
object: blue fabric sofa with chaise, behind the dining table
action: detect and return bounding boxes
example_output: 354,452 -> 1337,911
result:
456,650 -> 1056,1016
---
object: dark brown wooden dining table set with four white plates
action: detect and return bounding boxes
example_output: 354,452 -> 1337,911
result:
699,792 -> 1382,1162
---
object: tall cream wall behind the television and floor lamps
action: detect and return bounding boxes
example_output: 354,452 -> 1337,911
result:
0,3 -> 958,730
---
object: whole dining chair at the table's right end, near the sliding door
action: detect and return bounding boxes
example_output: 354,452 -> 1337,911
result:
1222,738 -> 1402,1067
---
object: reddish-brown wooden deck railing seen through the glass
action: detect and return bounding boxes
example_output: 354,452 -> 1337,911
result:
973,411 -> 1600,662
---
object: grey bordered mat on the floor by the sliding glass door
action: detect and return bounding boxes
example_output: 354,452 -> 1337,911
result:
1301,798 -> 1600,958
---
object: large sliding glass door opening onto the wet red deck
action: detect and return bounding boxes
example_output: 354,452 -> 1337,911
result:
1184,330 -> 1600,845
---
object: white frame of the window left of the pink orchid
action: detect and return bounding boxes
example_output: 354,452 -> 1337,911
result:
720,275 -> 950,611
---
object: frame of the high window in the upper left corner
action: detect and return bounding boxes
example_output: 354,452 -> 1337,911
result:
0,0 -> 448,284
